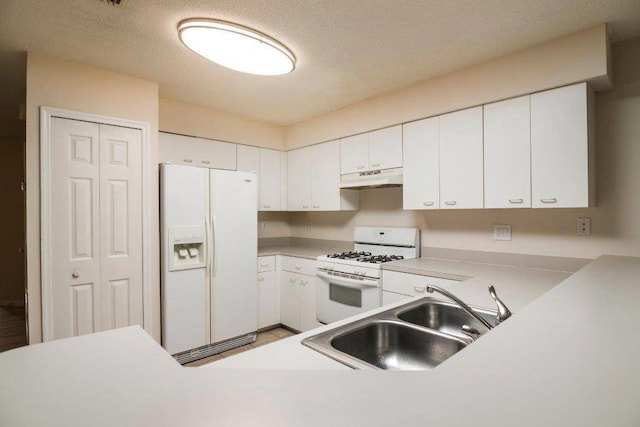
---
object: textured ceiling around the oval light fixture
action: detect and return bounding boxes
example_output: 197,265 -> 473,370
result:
0,0 -> 640,124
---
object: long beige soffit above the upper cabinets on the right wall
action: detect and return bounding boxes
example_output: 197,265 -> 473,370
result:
285,25 -> 609,150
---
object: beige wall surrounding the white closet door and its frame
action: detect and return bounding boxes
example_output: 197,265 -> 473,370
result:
26,54 -> 160,343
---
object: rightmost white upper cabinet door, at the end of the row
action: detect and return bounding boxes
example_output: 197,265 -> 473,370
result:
531,83 -> 589,208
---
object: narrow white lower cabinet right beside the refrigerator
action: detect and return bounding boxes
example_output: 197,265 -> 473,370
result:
258,256 -> 280,329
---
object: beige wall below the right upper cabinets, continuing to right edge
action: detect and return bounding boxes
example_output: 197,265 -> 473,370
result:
291,38 -> 640,258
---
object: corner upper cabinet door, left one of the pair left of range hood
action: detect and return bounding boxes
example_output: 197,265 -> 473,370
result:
287,147 -> 312,211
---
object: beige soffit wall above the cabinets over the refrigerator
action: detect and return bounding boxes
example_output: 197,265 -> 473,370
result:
159,98 -> 284,150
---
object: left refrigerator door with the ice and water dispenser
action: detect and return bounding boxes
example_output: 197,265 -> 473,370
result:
160,164 -> 209,354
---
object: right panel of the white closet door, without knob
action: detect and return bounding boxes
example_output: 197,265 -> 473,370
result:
100,125 -> 142,330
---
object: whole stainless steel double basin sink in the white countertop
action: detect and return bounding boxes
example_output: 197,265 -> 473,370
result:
302,297 -> 496,370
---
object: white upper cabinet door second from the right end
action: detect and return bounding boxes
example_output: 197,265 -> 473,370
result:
484,95 -> 531,208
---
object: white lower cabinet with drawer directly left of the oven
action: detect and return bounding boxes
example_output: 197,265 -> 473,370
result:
280,257 -> 321,331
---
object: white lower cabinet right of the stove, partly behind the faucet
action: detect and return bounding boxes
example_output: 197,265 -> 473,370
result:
382,270 -> 459,306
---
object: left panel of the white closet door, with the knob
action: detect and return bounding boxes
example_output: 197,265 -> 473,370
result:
50,118 -> 102,339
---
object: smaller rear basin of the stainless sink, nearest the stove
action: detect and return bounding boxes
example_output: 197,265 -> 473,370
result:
396,300 -> 496,338
